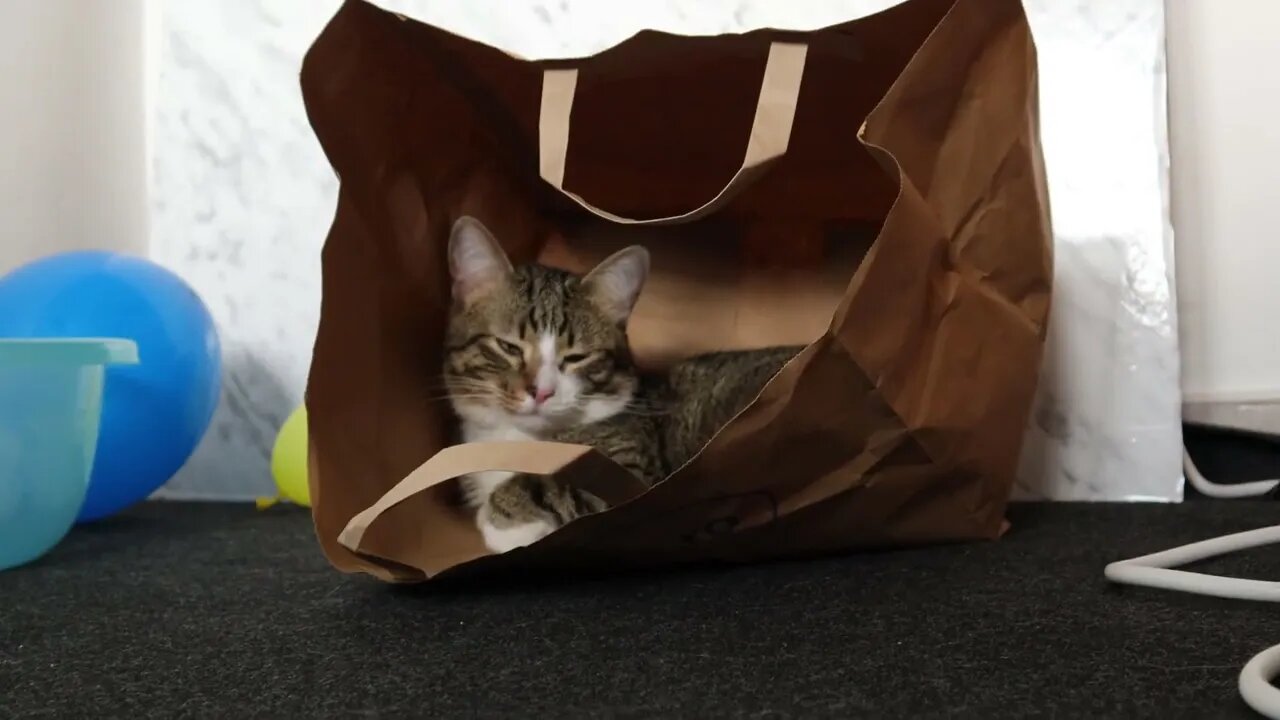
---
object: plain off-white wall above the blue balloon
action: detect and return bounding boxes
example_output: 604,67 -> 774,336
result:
0,0 -> 147,273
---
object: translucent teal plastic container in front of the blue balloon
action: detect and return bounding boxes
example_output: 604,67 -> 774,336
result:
0,338 -> 138,570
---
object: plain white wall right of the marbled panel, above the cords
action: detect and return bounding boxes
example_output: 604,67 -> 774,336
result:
1167,0 -> 1280,404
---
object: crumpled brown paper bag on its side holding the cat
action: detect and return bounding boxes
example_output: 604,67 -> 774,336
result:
302,0 -> 1052,582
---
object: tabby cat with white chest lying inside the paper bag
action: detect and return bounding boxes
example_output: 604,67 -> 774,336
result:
444,218 -> 800,552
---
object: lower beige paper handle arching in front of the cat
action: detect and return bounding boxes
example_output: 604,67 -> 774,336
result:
338,442 -> 645,551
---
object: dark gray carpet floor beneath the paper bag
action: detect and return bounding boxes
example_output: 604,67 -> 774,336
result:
0,501 -> 1280,719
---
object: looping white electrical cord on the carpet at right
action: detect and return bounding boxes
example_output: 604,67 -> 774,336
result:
1106,448 -> 1280,720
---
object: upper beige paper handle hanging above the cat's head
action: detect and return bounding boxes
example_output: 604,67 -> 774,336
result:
538,42 -> 809,225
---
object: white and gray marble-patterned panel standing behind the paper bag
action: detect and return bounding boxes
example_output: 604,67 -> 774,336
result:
150,0 -> 1181,500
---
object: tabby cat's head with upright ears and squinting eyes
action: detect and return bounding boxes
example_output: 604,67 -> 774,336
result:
444,218 -> 649,436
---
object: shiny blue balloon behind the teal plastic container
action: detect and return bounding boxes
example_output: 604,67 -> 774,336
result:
0,251 -> 221,521
